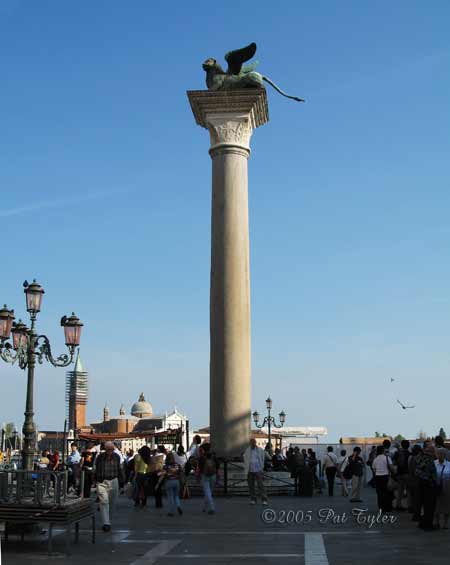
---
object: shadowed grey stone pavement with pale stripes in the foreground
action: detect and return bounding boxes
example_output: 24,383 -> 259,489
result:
1,482 -> 450,565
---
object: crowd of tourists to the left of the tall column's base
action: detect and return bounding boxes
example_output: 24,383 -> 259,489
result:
47,436 -> 219,532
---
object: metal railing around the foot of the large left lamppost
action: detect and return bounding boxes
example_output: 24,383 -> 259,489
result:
0,469 -> 68,506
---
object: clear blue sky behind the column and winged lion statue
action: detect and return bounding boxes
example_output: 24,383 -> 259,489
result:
0,0 -> 450,439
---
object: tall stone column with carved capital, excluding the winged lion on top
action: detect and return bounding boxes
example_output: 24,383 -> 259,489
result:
188,89 -> 268,457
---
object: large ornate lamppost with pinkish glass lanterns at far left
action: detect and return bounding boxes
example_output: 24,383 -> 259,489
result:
0,280 -> 83,471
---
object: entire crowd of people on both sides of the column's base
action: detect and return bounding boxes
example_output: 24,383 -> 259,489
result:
1,436 -> 450,532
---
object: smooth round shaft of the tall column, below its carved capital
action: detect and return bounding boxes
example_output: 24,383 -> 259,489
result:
210,146 -> 251,457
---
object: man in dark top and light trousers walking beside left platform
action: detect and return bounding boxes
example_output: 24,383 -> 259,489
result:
94,441 -> 125,532
